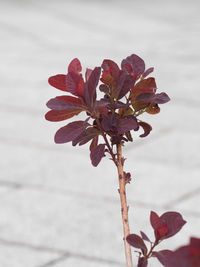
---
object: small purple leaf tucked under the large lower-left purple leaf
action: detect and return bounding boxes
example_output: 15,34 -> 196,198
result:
72,127 -> 100,146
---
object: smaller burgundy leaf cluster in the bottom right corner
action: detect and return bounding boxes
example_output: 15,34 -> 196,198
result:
126,211 -> 189,267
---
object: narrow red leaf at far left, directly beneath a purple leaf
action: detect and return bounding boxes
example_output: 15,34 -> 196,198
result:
45,110 -> 82,122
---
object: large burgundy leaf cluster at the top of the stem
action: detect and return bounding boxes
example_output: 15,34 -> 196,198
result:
45,54 -> 169,166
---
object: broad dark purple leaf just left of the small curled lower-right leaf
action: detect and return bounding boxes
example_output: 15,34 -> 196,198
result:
118,116 -> 139,134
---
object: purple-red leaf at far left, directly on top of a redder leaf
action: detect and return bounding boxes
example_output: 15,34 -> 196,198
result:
47,96 -> 83,110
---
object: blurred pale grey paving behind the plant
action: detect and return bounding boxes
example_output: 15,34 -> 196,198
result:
0,0 -> 200,267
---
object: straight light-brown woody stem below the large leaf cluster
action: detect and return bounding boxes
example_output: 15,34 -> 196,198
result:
117,144 -> 133,267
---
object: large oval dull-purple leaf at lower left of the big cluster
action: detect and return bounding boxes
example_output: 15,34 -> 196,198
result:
54,121 -> 89,144
